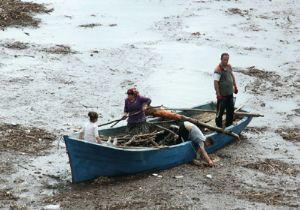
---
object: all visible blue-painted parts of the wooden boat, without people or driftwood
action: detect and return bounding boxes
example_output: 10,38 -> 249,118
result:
64,103 -> 252,183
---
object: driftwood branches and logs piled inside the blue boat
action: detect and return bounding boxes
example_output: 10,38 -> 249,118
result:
99,107 -> 253,147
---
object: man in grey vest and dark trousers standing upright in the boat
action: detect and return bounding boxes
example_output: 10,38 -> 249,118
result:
214,53 -> 238,127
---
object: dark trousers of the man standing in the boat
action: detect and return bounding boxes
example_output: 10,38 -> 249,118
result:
216,95 -> 234,128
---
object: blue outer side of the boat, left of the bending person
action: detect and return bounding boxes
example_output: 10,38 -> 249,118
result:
64,136 -> 196,183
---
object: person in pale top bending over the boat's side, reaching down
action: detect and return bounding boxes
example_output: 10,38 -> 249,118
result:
178,121 -> 213,166
